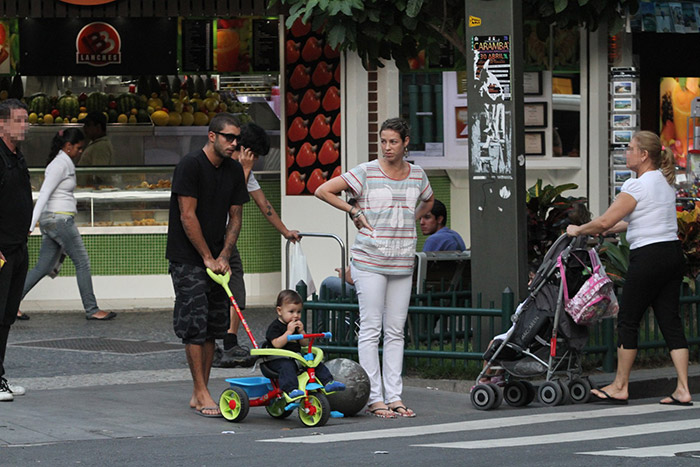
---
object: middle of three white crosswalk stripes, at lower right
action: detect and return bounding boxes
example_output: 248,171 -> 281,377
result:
413,420 -> 698,449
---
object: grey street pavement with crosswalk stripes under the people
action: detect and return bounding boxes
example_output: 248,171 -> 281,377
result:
0,308 -> 700,465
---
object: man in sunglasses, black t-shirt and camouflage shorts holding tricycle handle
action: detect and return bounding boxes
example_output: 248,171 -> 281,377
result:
165,113 -> 248,417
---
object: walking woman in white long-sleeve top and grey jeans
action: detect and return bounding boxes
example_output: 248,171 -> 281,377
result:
22,128 -> 116,320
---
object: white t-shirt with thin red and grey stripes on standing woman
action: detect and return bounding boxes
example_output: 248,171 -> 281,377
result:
341,160 -> 433,275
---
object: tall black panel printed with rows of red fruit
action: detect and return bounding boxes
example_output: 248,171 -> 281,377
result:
284,20 -> 341,195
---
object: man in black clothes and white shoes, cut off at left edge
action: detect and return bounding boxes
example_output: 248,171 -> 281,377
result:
0,99 -> 33,401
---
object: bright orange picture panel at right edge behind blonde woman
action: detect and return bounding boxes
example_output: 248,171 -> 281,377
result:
659,78 -> 700,167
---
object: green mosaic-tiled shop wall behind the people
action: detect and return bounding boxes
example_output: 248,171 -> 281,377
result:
29,175 -> 451,276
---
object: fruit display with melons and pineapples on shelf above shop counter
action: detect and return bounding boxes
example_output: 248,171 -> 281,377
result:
23,75 -> 253,126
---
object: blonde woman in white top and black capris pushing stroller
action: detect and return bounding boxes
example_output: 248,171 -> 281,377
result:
566,131 -> 692,405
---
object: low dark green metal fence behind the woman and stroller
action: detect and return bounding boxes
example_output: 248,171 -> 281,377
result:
300,282 -> 700,372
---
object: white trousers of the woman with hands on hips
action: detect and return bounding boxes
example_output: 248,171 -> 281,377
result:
351,266 -> 412,405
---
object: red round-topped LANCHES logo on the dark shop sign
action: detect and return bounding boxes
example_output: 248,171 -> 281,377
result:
75,22 -> 122,66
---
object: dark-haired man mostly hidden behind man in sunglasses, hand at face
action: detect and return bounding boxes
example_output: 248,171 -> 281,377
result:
213,123 -> 299,368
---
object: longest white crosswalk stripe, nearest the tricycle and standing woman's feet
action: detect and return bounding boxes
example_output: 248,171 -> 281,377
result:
258,404 -> 700,444
